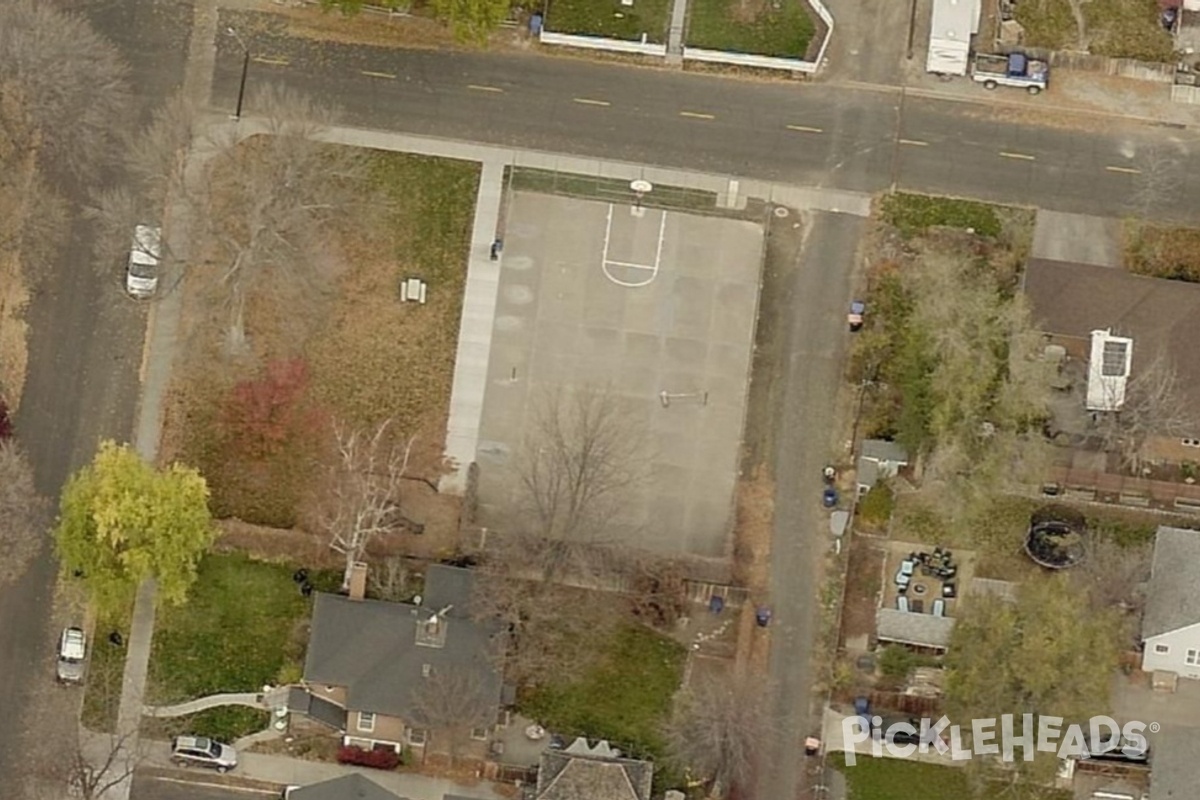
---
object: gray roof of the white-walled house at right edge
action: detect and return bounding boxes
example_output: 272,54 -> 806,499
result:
1141,525 -> 1200,639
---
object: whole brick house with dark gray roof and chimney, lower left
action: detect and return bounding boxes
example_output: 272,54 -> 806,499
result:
300,565 -> 504,758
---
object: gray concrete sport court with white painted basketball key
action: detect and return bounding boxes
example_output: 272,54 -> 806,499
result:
476,192 -> 763,557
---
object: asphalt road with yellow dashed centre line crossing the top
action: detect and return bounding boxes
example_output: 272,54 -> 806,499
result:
214,11 -> 1200,216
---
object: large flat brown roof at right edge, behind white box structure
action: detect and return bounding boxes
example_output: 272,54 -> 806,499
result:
1025,259 -> 1200,389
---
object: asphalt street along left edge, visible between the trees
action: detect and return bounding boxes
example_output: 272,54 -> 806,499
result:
0,0 -> 191,776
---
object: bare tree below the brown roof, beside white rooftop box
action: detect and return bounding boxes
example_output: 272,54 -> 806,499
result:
1092,355 -> 1200,470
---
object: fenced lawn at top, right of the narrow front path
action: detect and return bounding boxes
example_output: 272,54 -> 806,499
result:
685,0 -> 816,59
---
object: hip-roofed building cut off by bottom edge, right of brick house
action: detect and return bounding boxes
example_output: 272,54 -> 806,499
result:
534,739 -> 654,800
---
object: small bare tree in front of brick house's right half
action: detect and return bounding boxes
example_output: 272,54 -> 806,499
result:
412,667 -> 499,759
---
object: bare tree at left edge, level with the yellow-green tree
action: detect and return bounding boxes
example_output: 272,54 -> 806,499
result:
0,439 -> 48,579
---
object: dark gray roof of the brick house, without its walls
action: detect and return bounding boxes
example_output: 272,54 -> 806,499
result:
304,567 -> 502,718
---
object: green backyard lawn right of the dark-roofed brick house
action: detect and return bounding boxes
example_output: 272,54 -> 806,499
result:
521,626 -> 685,757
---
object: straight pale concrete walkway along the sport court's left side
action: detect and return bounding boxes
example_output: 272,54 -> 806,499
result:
433,157 -> 504,494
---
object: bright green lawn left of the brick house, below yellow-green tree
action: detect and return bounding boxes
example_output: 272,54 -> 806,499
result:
148,554 -> 341,741
